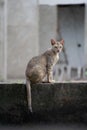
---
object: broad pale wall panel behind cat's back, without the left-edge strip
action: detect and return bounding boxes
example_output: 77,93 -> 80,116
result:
7,0 -> 38,78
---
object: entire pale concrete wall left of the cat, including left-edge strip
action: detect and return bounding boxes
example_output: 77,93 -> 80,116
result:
0,0 -> 39,81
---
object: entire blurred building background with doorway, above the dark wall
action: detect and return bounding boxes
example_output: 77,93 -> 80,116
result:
0,0 -> 87,82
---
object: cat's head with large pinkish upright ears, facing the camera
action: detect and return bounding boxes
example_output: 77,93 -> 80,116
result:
51,39 -> 64,53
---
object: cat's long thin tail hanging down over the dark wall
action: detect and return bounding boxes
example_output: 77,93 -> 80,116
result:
26,78 -> 33,112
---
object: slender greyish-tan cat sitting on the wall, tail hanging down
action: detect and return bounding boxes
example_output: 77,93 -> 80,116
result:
25,39 -> 64,112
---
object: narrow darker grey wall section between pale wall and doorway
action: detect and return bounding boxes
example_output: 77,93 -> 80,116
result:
39,5 -> 57,53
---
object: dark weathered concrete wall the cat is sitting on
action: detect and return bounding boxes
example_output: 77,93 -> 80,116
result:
0,83 -> 87,123
